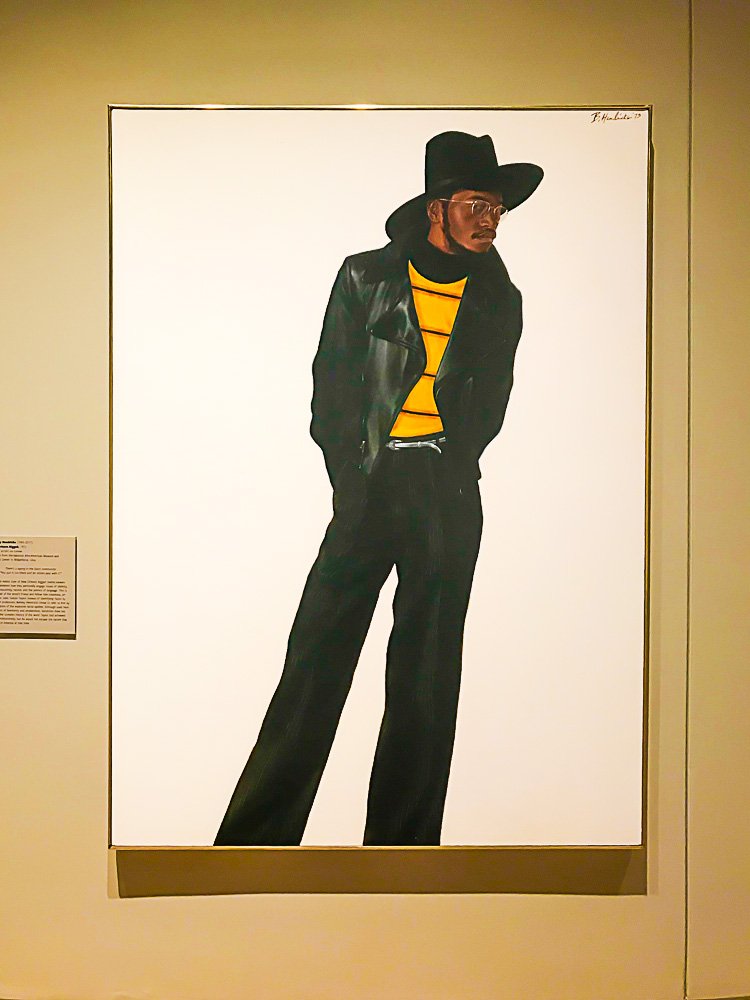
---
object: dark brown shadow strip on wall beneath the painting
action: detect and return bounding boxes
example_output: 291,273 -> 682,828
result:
111,847 -> 647,897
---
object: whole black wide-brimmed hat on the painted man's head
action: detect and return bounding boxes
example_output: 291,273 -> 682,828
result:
385,132 -> 544,239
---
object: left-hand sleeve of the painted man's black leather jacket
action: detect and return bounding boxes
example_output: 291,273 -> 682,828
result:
310,258 -> 367,485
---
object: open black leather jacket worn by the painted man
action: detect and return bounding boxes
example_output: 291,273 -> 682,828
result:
310,234 -> 522,487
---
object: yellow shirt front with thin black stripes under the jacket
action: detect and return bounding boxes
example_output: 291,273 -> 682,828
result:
391,261 -> 467,438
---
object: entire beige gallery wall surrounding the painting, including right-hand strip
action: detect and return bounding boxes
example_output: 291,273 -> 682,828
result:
0,0 -> 750,1000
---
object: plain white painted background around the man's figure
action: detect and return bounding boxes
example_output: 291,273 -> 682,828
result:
112,110 -> 647,844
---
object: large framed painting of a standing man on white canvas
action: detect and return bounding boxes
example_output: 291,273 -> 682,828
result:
111,107 -> 650,847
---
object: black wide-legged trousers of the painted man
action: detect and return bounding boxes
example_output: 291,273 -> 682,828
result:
215,448 -> 482,845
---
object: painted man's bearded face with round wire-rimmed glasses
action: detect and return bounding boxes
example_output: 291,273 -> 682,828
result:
427,188 -> 503,253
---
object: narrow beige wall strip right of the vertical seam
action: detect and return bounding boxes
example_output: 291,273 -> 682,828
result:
688,0 -> 750,997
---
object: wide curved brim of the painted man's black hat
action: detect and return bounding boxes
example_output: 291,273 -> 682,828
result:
385,163 -> 544,240
